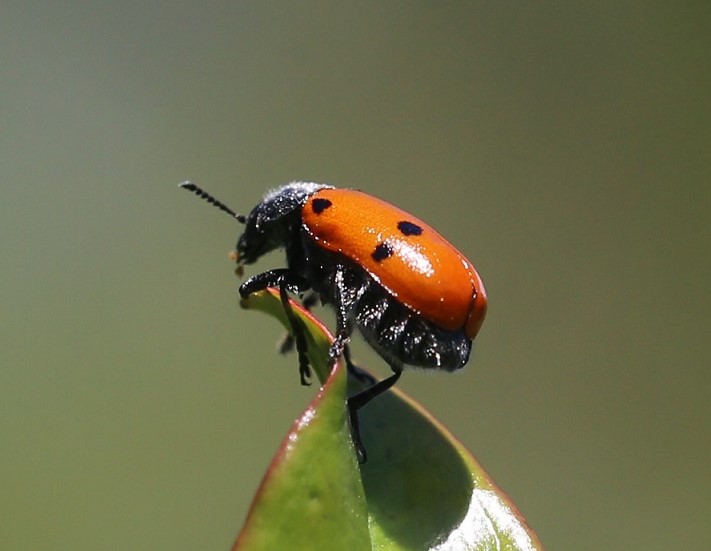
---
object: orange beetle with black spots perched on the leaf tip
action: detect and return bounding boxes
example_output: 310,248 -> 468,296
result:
180,182 -> 487,461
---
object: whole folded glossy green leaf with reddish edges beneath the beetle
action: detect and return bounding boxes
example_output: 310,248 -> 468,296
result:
234,292 -> 543,551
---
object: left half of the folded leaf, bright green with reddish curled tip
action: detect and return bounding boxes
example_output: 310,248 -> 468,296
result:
233,292 -> 371,551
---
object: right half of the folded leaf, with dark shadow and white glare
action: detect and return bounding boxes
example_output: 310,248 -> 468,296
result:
361,380 -> 543,551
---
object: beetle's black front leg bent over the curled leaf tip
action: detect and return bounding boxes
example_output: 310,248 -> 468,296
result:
239,268 -> 311,385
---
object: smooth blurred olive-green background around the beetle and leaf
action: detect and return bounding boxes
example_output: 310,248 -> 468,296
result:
0,0 -> 711,550
